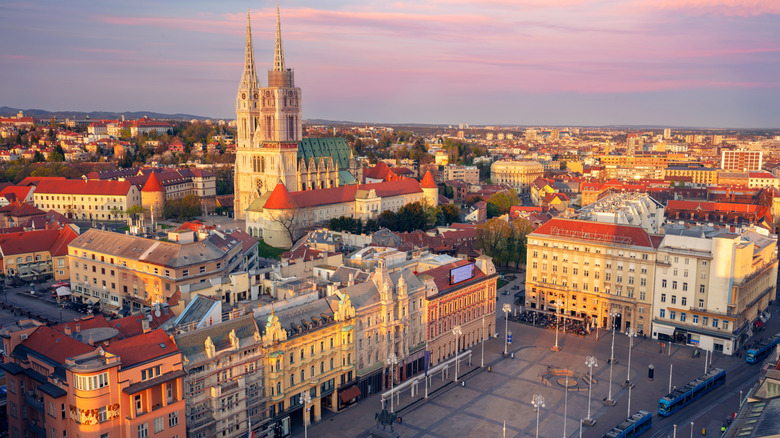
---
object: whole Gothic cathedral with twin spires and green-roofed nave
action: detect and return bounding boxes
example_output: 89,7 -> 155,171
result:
234,6 -> 362,219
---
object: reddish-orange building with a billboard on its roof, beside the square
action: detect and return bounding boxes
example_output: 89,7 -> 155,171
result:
417,255 -> 498,365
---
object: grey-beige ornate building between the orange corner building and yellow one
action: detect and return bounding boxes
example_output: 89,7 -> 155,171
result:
175,314 -> 268,438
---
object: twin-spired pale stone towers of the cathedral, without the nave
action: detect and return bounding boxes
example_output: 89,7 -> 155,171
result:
233,6 -> 302,219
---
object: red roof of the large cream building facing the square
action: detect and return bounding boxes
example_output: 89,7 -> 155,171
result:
531,218 -> 653,248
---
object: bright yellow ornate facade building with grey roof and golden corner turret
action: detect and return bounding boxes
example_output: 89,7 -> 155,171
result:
258,293 -> 359,435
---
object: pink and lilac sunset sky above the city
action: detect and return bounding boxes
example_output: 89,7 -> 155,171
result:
0,0 -> 780,128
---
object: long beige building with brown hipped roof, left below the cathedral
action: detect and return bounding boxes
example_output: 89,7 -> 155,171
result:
68,228 -> 250,311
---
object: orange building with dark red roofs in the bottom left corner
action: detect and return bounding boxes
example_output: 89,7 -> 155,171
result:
0,320 -> 186,437
